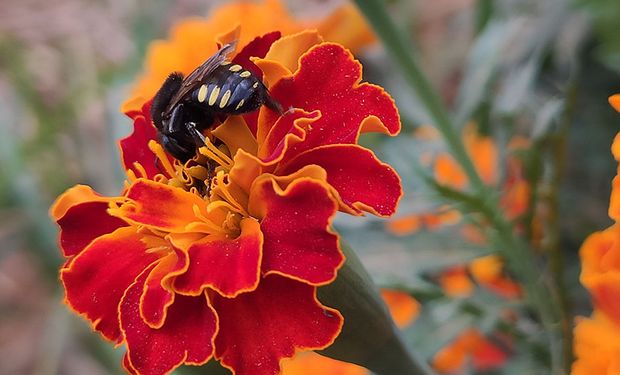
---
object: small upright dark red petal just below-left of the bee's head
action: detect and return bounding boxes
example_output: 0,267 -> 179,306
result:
119,101 -> 173,179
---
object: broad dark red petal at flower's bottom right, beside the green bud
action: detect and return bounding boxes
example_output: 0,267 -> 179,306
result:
213,275 -> 343,375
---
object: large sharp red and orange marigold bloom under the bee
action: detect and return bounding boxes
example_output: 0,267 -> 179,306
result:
50,16 -> 402,375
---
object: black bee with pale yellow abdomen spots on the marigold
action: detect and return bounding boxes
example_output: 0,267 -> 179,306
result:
151,42 -> 282,163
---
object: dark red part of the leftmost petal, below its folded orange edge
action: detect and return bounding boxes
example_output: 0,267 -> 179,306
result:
58,202 -> 127,257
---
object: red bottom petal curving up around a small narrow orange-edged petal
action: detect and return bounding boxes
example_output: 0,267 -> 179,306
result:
119,269 -> 217,375
